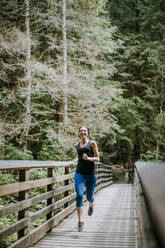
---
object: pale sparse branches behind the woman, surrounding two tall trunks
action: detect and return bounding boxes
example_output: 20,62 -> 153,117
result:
0,0 -> 122,160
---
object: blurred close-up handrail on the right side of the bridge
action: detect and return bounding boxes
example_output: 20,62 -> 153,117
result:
135,161 -> 165,248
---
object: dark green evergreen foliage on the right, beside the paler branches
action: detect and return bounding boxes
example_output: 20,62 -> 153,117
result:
106,0 -> 165,164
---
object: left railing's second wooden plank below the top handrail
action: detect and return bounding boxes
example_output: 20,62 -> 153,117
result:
0,183 -> 74,218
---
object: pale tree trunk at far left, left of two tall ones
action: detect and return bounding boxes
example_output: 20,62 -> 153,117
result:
23,0 -> 31,150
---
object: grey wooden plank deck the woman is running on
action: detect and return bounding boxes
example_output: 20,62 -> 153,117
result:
35,184 -> 139,248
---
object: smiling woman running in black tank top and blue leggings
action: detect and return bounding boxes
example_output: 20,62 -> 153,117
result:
74,126 -> 100,232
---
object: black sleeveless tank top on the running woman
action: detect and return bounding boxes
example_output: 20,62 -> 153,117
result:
76,141 -> 96,175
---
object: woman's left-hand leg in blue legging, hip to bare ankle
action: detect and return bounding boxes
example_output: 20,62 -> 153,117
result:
74,172 -> 84,222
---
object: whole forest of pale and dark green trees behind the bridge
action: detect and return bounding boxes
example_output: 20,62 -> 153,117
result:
0,0 -> 165,168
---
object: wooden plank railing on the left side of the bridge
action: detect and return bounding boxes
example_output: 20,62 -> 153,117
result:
0,161 -> 112,248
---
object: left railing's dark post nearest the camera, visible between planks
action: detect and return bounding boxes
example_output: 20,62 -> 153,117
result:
18,170 -> 29,239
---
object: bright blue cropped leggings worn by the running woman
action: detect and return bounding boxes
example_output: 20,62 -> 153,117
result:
74,172 -> 96,207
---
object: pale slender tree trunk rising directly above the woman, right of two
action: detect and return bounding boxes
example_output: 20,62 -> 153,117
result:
63,0 -> 68,125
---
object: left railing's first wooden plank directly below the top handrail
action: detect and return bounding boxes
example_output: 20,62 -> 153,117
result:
0,173 -> 74,196
